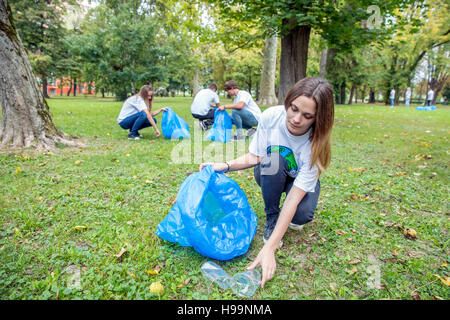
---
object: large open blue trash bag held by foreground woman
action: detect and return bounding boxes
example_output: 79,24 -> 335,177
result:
156,166 -> 257,260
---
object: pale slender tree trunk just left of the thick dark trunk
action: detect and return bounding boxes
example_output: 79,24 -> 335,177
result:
258,36 -> 278,106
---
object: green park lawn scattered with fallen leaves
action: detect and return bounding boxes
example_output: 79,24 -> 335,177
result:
0,96 -> 450,300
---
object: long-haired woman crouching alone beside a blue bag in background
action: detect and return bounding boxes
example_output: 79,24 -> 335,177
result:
117,85 -> 166,140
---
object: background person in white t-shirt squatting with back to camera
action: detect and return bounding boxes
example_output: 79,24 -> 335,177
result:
191,83 -> 220,131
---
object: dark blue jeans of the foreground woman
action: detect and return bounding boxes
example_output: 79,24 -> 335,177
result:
254,153 -> 320,225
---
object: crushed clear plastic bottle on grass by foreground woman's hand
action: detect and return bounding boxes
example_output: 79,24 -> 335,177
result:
201,261 -> 261,298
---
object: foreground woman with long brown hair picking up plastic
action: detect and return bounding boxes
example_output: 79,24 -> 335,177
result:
200,78 -> 334,286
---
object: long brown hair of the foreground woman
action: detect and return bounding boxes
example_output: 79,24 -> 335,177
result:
284,77 -> 334,176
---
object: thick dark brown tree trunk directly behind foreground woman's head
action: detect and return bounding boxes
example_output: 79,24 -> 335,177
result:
278,19 -> 311,104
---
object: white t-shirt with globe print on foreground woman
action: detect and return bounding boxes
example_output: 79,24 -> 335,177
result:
249,105 -> 319,192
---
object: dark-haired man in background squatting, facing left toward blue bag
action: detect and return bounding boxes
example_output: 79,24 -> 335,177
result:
219,80 -> 261,140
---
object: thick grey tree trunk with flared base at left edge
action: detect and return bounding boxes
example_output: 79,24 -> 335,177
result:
0,0 -> 79,149
